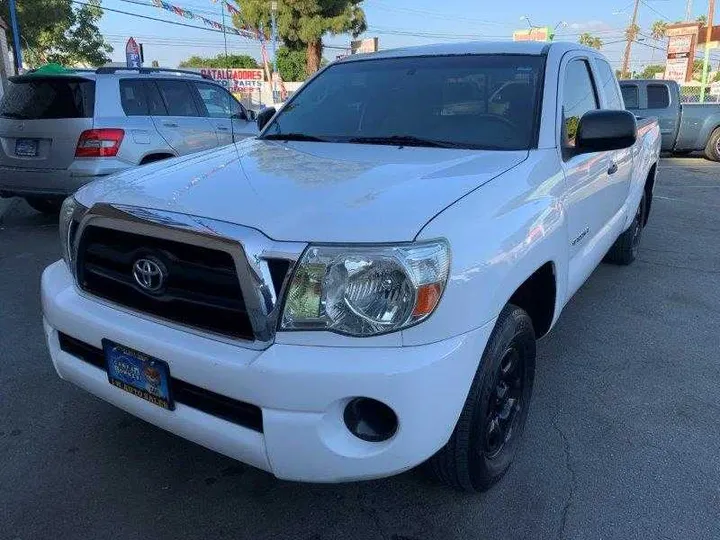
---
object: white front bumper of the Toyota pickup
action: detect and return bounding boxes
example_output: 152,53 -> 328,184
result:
42,261 -> 494,482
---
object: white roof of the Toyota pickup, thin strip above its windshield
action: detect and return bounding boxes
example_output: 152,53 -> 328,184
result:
339,41 -> 598,62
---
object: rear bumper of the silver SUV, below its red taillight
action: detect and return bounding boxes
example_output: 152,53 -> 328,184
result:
0,158 -> 131,197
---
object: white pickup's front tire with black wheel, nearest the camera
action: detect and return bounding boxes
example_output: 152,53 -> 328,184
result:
428,304 -> 535,493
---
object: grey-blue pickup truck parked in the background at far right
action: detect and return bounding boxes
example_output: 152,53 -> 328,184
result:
620,79 -> 720,161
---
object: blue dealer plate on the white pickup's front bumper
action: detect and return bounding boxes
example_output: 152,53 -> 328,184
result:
103,339 -> 175,411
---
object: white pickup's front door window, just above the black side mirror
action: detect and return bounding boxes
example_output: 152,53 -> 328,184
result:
563,60 -> 599,147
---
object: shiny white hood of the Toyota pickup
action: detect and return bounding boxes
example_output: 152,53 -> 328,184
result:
76,139 -> 528,242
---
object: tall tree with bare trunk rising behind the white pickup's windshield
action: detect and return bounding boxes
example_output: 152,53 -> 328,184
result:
233,0 -> 367,74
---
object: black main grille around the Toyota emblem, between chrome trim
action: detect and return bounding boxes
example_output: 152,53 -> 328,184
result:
77,225 -> 254,339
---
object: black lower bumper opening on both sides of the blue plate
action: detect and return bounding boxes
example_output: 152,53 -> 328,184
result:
58,332 -> 263,433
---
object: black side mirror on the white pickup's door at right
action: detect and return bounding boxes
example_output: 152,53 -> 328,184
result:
575,111 -> 637,154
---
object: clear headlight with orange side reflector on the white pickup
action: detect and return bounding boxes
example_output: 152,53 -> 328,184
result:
281,241 -> 450,336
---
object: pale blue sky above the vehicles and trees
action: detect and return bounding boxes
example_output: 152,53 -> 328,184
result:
100,0 -> 720,71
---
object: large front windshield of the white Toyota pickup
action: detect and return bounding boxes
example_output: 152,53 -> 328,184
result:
263,55 -> 543,150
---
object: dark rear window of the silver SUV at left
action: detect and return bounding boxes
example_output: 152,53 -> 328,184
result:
0,77 -> 95,120
